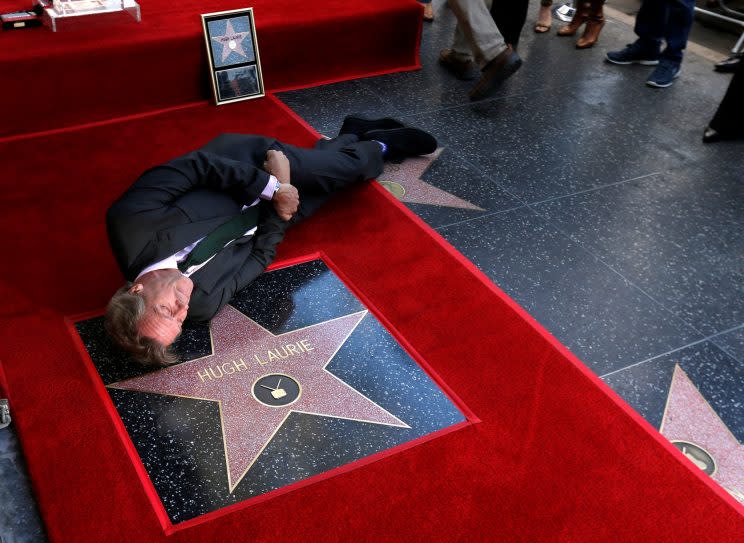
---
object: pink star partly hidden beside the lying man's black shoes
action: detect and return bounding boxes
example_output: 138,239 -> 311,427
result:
378,147 -> 485,211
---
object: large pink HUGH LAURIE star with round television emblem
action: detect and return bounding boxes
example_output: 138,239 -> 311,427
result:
108,305 -> 410,493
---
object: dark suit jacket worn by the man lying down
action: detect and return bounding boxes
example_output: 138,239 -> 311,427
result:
106,136 -> 287,320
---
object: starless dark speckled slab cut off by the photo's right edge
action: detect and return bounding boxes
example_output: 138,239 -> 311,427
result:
535,163 -> 744,334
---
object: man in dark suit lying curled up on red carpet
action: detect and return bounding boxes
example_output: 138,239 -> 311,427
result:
101,116 -> 437,365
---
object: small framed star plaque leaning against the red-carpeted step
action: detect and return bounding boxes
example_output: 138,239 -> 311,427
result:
202,8 -> 265,106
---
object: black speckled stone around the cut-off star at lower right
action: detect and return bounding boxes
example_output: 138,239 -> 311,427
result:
604,341 -> 744,442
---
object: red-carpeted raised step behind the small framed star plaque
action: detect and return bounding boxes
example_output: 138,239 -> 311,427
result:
0,0 -> 421,137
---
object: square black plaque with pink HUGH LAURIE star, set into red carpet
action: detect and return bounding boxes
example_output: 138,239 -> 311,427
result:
75,257 -> 473,526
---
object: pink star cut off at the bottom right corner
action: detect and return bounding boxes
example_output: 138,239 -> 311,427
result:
659,365 -> 744,503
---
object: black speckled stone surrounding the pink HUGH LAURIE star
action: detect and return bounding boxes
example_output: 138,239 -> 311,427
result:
72,260 -> 465,523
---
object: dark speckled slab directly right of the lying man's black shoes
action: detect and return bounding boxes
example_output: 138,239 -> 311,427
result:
402,94 -> 682,203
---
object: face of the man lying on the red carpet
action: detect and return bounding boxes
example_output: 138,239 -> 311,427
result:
129,270 -> 194,345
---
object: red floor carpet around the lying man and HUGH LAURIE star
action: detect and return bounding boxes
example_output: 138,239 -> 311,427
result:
0,98 -> 744,542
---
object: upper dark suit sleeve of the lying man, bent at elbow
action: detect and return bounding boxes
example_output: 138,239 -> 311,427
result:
111,150 -> 269,215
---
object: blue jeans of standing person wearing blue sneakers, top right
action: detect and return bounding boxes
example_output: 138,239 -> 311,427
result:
634,0 -> 695,62
